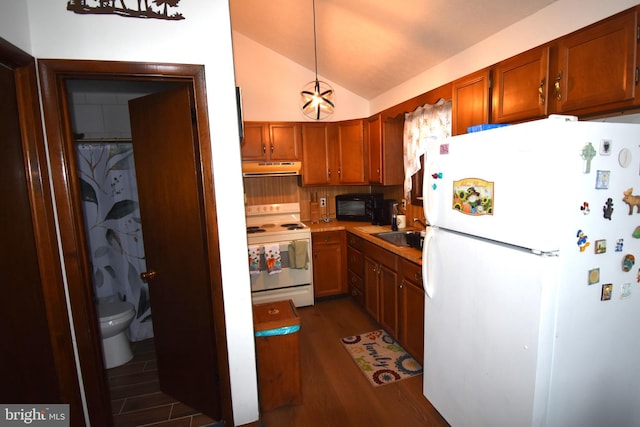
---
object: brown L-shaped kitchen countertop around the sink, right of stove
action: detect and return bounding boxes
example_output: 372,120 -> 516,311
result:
303,220 -> 422,264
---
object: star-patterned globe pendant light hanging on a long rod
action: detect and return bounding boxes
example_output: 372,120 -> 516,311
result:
300,0 -> 335,120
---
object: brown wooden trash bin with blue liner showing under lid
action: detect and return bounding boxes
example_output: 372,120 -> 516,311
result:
253,300 -> 302,411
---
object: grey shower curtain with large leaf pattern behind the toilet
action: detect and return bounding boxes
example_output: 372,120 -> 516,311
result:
76,141 -> 153,341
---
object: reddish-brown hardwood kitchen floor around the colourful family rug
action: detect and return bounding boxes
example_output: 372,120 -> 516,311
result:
262,297 -> 448,427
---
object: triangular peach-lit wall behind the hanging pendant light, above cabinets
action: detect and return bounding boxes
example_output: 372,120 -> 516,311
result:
233,31 -> 369,122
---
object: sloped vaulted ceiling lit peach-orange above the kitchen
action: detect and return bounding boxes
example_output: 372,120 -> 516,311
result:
230,0 -> 555,99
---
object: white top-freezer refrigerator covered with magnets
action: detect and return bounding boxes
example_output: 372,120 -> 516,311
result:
423,116 -> 640,427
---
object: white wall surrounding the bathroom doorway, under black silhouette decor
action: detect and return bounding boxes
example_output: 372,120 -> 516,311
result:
18,0 -> 258,424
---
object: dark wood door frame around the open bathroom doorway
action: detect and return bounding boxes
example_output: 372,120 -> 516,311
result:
38,59 -> 233,425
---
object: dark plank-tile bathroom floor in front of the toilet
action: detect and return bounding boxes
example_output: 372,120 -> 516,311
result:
107,339 -> 215,427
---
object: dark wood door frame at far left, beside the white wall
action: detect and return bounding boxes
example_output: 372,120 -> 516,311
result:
0,38 -> 84,425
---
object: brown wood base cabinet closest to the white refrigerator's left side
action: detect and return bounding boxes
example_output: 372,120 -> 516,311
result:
398,259 -> 424,364
